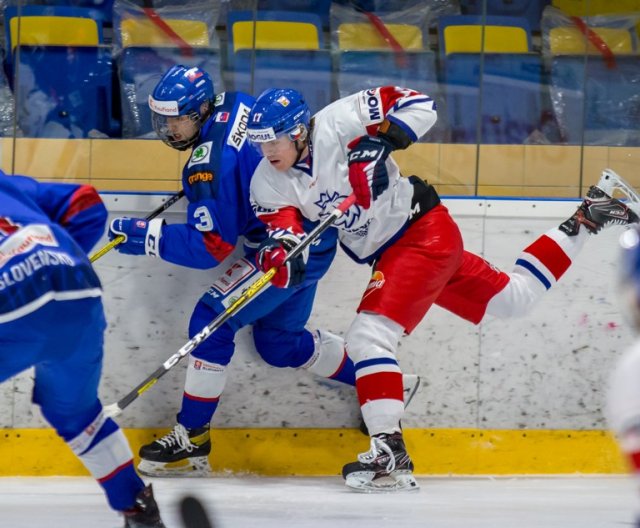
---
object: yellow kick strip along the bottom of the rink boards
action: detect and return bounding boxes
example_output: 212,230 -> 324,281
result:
0,429 -> 626,476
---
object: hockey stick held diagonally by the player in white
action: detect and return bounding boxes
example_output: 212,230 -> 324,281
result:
104,194 -> 356,417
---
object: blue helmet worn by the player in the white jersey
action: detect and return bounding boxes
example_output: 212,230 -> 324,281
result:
247,88 -> 311,144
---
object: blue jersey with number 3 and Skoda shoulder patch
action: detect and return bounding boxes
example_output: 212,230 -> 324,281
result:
154,92 -> 337,279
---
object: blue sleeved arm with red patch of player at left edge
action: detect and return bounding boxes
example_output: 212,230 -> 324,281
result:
11,176 -> 108,253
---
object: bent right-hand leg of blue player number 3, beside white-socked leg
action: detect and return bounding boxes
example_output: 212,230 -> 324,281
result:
253,282 -> 355,385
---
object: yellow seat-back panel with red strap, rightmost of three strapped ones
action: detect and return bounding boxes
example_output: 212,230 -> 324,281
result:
549,27 -> 634,55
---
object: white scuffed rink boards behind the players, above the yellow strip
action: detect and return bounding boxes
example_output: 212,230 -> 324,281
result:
0,194 -> 632,429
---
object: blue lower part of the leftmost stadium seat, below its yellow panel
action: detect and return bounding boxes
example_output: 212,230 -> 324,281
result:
14,46 -> 120,138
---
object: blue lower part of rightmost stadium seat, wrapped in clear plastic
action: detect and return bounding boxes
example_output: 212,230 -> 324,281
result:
551,55 -> 640,146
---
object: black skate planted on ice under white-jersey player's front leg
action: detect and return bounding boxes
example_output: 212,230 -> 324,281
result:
342,433 -> 420,493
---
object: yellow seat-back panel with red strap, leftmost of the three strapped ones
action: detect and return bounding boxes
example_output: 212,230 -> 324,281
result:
120,18 -> 209,48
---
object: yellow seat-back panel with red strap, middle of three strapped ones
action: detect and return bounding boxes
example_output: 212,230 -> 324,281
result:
338,23 -> 423,50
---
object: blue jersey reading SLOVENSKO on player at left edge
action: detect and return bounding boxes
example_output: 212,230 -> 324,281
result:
0,171 -> 107,323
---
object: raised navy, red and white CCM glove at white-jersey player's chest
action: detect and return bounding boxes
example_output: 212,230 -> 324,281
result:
347,136 -> 393,209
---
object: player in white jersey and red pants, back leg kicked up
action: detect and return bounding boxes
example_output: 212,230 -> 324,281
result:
249,86 -> 638,491
